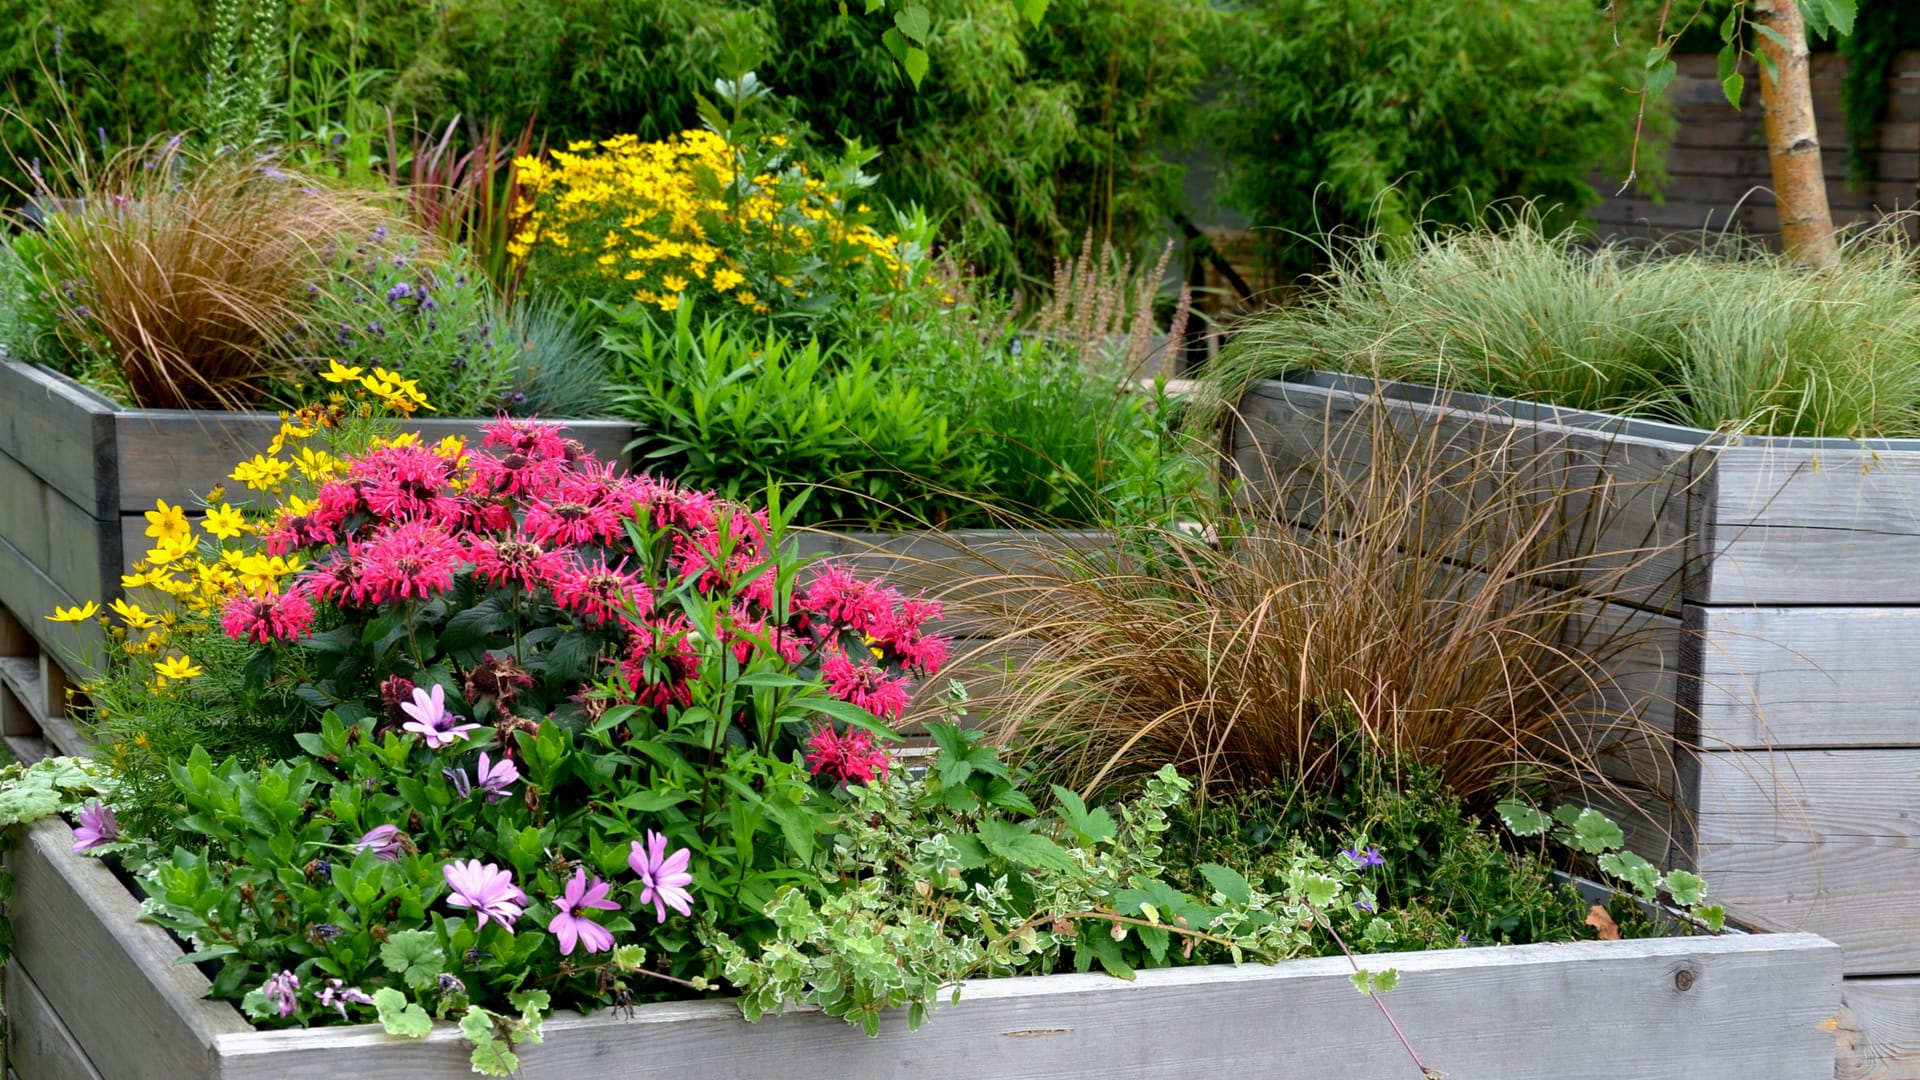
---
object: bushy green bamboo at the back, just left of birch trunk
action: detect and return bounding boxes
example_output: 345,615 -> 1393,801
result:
1208,0 -> 1659,265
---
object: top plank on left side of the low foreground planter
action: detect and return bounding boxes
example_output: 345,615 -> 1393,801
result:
6,819 -> 252,1080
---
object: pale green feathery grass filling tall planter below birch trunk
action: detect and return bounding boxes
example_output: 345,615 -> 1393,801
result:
1202,215 -> 1920,438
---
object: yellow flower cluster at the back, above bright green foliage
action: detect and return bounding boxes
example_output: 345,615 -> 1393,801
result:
509,131 -> 908,313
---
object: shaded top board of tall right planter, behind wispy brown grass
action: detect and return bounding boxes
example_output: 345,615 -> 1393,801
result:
1229,379 -> 1703,615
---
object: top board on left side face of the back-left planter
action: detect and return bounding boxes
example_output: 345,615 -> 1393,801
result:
0,361 -> 115,517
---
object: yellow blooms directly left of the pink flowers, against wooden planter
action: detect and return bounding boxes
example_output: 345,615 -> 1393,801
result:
48,361 -> 439,690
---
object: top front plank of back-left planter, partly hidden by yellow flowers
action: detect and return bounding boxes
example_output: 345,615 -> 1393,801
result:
113,409 -> 634,513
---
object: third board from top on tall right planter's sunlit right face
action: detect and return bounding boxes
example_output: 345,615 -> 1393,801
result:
1697,749 -> 1920,974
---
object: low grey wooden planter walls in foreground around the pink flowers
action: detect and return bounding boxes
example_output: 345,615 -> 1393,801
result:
6,821 -> 1839,1080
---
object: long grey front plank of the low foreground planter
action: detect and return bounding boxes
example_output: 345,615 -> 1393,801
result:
217,934 -> 1839,1080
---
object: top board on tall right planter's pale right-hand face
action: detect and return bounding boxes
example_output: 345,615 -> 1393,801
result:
1688,444 -> 1920,605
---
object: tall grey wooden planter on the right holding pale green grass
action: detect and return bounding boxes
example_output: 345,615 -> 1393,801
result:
1231,373 -> 1920,1076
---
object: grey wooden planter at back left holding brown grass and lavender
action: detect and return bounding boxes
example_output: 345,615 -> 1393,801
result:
0,361 -> 634,680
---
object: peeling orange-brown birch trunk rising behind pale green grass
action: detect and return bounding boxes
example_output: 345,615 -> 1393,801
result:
1753,0 -> 1839,267
